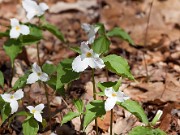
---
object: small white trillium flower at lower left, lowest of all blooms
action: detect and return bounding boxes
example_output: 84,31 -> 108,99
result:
27,104 -> 44,122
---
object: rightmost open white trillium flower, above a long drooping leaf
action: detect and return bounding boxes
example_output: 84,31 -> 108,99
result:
104,87 -> 129,111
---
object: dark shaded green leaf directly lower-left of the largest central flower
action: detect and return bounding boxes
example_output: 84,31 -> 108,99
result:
56,59 -> 80,94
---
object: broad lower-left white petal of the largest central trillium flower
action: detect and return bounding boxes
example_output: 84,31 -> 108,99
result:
72,55 -> 88,72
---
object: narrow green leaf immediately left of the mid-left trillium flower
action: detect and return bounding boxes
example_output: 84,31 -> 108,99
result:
12,72 -> 30,90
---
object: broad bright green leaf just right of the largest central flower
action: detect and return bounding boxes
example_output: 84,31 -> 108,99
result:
103,54 -> 134,80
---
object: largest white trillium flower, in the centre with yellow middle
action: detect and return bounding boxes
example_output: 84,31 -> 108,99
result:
72,42 -> 105,72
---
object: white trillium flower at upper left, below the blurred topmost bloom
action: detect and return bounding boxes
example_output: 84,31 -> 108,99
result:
10,18 -> 30,38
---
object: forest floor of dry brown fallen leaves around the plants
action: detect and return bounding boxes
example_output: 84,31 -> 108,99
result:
0,0 -> 180,135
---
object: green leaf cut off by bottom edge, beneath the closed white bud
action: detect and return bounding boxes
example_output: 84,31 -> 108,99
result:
128,126 -> 166,135
